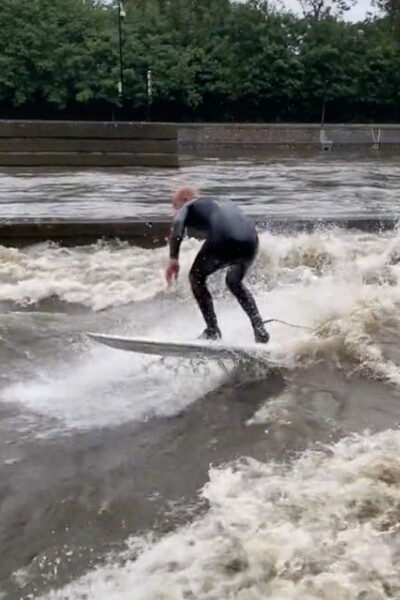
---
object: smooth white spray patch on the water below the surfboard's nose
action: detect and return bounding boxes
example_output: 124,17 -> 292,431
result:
1,340 -> 230,434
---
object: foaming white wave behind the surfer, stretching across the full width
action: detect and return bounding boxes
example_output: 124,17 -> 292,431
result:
0,229 -> 400,386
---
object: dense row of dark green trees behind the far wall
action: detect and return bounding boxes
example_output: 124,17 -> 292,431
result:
0,0 -> 400,122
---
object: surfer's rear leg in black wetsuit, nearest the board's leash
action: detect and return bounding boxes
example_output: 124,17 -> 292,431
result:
226,243 -> 269,343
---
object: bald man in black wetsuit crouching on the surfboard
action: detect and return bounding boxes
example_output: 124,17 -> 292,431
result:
165,187 -> 269,344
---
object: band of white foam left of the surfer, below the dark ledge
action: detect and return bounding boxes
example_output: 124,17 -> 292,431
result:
0,243 -> 174,311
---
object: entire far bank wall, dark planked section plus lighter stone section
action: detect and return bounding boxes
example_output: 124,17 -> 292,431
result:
0,120 -> 400,170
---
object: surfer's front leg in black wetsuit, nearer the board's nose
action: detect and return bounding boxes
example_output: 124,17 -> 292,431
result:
189,240 -> 227,339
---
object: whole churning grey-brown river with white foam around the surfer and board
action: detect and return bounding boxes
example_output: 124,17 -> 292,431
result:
0,156 -> 400,600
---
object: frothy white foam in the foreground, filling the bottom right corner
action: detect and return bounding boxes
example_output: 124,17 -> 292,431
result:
39,431 -> 400,600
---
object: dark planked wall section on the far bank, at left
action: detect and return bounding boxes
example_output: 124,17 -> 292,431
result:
0,120 -> 179,167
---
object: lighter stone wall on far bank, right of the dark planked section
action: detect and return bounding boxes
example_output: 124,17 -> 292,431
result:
178,123 -> 400,155
